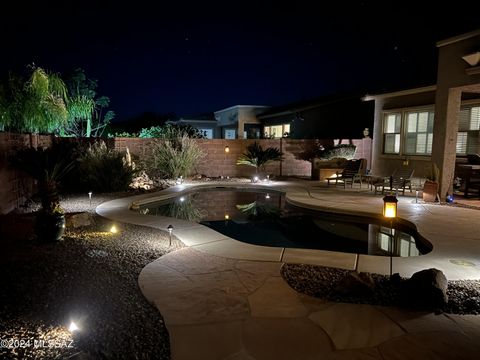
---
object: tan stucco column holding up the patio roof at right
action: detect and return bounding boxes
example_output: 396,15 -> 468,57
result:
432,88 -> 462,200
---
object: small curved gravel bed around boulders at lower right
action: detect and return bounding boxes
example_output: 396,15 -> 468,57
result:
281,264 -> 480,315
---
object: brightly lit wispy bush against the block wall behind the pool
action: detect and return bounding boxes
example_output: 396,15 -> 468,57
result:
146,134 -> 205,179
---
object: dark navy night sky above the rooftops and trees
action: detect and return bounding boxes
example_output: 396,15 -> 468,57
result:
0,0 -> 480,120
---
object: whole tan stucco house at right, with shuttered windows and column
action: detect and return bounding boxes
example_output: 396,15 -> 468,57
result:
363,30 -> 480,199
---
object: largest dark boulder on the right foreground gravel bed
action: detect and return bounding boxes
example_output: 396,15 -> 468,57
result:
402,268 -> 448,310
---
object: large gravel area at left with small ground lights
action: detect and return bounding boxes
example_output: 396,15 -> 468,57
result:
0,194 -> 183,359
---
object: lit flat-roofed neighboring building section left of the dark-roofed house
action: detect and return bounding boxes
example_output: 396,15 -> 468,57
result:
214,105 -> 269,139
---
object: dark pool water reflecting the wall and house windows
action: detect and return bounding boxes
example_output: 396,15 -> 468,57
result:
139,188 -> 430,256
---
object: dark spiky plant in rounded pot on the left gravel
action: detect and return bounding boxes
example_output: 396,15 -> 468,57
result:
11,148 -> 73,242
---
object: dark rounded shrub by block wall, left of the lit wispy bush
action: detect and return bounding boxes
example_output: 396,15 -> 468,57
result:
80,141 -> 135,192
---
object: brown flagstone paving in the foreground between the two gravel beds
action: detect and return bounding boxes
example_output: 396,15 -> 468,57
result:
139,248 -> 480,360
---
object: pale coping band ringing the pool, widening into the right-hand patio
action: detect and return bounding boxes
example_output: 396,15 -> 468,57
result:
96,182 -> 480,280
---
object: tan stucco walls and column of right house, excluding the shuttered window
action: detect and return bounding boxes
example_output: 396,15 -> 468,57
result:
363,30 -> 480,199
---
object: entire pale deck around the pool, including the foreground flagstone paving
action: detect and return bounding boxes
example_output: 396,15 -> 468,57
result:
97,182 -> 480,359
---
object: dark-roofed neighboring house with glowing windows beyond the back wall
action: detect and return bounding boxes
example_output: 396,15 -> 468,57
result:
258,94 -> 373,139
